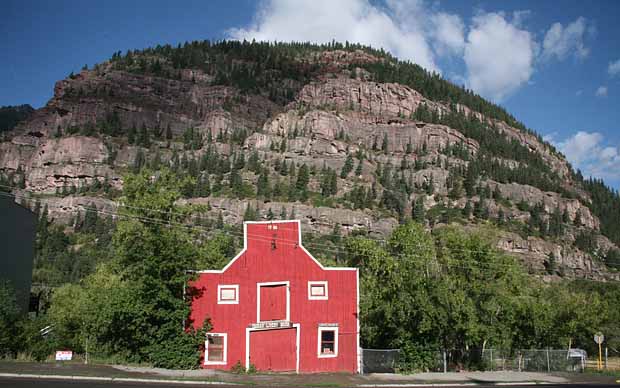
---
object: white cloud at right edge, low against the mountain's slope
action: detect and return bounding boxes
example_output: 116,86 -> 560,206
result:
557,131 -> 620,180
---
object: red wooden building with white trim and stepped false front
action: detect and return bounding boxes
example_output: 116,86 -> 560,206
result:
190,221 -> 360,372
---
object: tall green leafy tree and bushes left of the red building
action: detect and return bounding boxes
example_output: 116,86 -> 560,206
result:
43,170 -> 212,368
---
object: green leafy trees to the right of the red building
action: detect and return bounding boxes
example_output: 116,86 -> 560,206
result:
346,223 -> 619,370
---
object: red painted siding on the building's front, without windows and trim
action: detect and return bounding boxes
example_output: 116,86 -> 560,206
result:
190,221 -> 359,372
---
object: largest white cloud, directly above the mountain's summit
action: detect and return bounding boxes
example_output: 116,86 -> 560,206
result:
228,0 -> 439,71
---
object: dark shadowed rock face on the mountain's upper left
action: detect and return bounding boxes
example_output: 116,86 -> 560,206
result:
17,66 -> 280,137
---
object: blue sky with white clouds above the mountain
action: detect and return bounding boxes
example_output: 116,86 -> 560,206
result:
0,0 -> 620,189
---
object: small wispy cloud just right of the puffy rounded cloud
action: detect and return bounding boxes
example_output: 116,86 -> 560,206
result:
541,17 -> 590,60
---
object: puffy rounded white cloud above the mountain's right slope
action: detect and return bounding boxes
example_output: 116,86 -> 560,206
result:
464,13 -> 536,100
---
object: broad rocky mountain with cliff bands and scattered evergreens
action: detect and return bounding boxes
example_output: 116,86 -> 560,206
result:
0,41 -> 620,279
